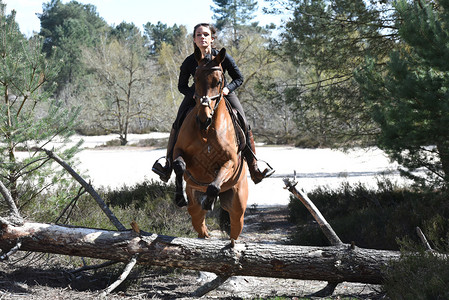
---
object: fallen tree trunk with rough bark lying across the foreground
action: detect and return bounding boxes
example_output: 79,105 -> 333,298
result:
0,223 -> 400,284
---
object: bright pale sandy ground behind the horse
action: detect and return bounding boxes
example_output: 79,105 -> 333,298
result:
65,133 -> 405,206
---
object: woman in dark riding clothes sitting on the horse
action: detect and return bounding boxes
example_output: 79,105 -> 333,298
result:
152,23 -> 274,184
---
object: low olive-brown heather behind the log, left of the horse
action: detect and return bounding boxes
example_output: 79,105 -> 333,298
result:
29,181 -> 196,237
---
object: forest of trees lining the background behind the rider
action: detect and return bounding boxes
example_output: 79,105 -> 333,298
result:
0,0 -> 449,298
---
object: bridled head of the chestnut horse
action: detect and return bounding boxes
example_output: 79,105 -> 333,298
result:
195,48 -> 226,129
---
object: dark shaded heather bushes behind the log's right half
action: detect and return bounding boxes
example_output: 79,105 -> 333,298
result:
289,182 -> 449,250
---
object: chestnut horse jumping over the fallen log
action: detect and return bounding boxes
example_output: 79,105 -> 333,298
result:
173,48 -> 248,241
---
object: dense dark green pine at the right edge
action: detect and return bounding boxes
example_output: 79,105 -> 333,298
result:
356,1 -> 449,186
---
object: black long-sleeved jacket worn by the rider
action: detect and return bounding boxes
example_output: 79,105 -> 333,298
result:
178,48 -> 243,98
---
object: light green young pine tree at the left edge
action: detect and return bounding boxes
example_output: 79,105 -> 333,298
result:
0,1 -> 78,219
